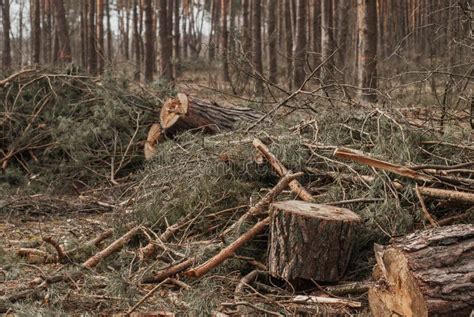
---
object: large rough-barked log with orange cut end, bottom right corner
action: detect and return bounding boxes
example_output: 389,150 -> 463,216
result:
369,224 -> 474,317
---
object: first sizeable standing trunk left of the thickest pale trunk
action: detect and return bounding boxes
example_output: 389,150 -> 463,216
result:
321,0 -> 335,84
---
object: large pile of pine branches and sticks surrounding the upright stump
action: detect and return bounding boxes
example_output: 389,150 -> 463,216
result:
1,99 -> 474,315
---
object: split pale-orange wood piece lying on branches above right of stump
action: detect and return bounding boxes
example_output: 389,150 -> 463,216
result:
334,148 -> 433,182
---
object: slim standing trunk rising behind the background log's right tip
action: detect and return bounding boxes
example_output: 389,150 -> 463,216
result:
252,0 -> 263,96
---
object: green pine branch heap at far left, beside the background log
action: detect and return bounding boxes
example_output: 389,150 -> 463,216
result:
0,69 -> 161,190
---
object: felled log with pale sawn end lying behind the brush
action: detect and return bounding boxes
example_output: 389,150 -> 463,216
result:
160,93 -> 263,136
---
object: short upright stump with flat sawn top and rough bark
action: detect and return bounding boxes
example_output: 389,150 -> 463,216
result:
268,200 -> 361,282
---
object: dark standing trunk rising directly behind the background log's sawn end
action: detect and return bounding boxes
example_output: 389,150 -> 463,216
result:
159,0 -> 173,81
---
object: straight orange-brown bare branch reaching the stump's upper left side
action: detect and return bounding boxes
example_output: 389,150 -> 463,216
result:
185,217 -> 270,278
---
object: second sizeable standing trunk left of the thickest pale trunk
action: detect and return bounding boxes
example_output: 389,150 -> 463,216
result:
293,0 -> 307,87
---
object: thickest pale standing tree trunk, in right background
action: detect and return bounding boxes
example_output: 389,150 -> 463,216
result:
357,0 -> 377,102
